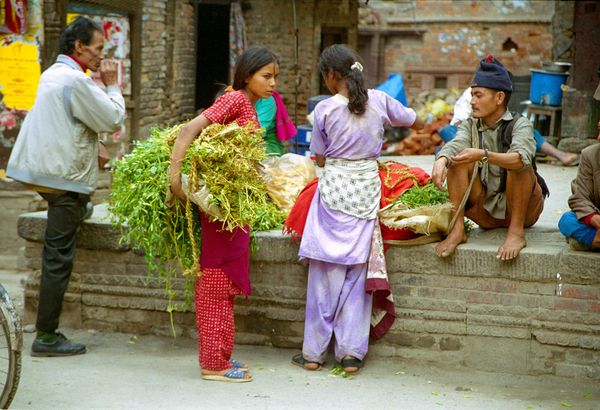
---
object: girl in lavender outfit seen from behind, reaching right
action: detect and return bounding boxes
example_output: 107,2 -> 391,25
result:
292,44 -> 423,373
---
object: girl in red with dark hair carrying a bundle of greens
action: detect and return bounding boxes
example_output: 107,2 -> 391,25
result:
170,47 -> 279,383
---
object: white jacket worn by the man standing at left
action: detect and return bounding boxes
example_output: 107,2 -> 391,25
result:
6,54 -> 125,194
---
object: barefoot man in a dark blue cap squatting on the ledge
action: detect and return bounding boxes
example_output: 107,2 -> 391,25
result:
432,56 -> 547,260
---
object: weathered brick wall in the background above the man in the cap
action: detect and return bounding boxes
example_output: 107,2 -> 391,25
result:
360,0 -> 554,95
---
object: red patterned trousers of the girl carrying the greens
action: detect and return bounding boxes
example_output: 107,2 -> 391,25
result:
194,269 -> 241,370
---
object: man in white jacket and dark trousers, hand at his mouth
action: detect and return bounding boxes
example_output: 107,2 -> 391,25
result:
6,16 -> 125,356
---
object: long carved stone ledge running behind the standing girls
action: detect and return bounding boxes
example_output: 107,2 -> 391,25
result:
19,207 -> 600,380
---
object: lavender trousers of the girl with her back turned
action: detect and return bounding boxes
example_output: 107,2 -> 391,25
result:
302,259 -> 372,363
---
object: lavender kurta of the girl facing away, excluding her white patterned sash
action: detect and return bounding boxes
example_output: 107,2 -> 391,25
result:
298,90 -> 416,265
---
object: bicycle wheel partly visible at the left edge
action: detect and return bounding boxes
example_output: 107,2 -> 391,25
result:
0,288 -> 21,409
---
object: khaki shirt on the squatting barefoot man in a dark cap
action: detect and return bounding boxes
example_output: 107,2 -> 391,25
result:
437,111 -> 535,219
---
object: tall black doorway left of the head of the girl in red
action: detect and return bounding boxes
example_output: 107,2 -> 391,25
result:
196,4 -> 230,110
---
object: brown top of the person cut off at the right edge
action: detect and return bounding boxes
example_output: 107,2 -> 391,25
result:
569,144 -> 600,219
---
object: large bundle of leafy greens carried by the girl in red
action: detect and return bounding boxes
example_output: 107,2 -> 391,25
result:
109,124 -> 284,310
